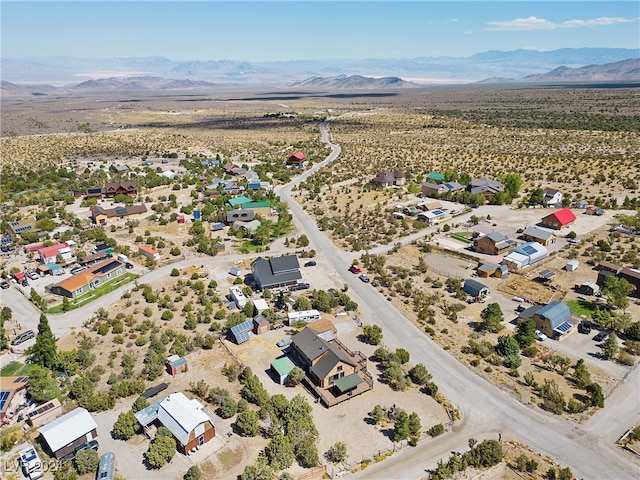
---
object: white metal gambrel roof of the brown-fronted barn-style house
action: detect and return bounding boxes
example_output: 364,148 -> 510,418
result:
158,392 -> 211,445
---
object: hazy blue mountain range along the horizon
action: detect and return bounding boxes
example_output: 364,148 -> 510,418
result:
0,48 -> 640,88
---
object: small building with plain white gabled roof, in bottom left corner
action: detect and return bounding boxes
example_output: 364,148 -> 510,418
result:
39,407 -> 98,459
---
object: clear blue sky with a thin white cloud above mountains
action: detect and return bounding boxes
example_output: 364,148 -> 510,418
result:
0,0 -> 640,62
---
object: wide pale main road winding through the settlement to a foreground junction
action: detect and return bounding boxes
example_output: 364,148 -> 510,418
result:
278,119 -> 640,479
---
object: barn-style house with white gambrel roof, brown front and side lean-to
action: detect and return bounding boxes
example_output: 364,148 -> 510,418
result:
134,392 -> 216,455
